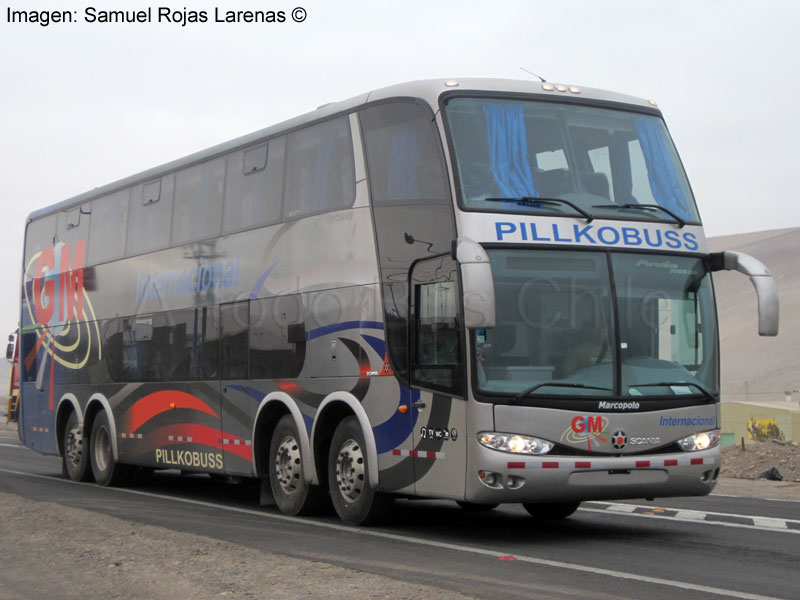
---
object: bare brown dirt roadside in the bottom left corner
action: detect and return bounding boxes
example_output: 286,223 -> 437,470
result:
0,493 -> 476,600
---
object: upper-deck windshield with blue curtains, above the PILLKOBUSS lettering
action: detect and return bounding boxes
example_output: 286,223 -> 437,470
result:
445,97 -> 699,223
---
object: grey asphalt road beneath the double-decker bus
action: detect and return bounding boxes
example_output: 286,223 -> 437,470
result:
0,426 -> 800,600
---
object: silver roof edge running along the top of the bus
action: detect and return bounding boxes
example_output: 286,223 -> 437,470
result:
27,78 -> 656,223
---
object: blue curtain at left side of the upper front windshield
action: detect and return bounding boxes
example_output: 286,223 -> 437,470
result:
483,102 -> 539,198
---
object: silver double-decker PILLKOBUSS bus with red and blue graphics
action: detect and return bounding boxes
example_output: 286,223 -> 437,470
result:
19,80 -> 778,524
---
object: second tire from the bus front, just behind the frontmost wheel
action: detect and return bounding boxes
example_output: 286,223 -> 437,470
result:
267,415 -> 326,515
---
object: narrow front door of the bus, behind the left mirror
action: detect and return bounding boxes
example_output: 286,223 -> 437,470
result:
410,255 -> 466,499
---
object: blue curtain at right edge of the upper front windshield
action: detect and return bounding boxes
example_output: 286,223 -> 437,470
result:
635,117 -> 692,219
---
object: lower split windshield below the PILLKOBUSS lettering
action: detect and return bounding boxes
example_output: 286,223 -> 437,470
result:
472,249 -> 718,401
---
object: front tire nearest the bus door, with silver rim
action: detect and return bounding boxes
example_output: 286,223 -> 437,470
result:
328,416 -> 394,525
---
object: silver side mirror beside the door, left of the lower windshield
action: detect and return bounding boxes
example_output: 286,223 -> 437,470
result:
453,238 -> 495,329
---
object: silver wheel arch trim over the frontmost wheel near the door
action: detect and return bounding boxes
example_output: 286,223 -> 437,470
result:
311,392 -> 378,489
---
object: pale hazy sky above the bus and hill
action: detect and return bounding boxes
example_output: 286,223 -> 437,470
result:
0,0 -> 800,342
